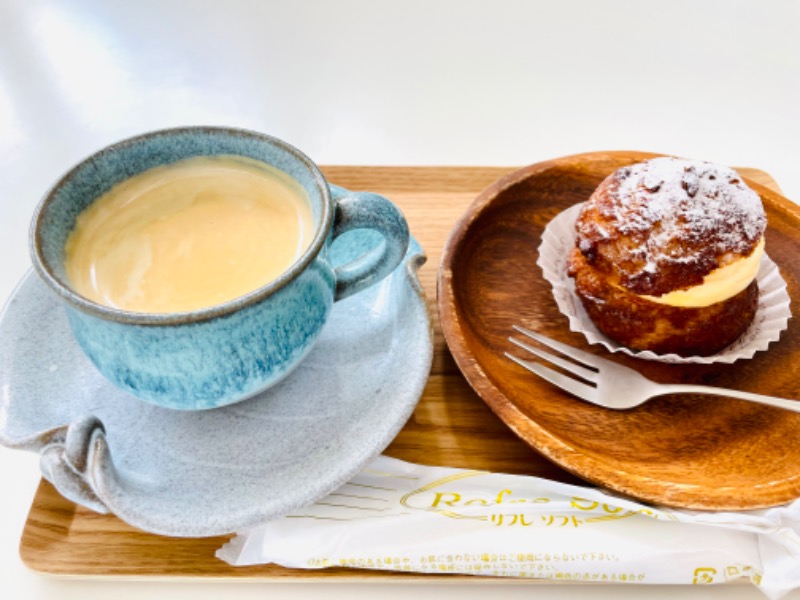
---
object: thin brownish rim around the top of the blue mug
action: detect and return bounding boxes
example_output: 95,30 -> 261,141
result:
28,125 -> 333,325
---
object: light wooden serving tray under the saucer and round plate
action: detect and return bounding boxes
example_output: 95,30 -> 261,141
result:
20,166 -> 780,581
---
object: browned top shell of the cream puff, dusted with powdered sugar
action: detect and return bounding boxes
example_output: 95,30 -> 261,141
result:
577,157 -> 766,296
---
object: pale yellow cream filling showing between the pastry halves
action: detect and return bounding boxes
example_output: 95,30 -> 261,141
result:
640,236 -> 764,308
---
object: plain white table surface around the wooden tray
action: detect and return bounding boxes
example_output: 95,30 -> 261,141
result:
0,0 -> 800,600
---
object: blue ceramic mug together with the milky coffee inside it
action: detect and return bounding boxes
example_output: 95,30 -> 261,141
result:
30,127 -> 409,410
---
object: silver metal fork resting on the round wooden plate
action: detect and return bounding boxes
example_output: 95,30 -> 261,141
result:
505,325 -> 800,412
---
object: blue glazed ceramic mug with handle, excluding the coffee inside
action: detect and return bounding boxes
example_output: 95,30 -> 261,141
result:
30,127 -> 409,410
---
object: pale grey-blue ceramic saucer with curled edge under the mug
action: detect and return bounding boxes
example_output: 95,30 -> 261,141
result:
0,231 -> 433,537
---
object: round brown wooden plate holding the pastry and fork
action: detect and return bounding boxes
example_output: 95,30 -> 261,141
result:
438,152 -> 800,510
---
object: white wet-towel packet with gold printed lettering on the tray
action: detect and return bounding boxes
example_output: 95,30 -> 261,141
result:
217,456 -> 800,599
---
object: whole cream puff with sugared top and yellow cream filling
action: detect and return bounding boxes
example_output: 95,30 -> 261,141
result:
567,157 -> 766,356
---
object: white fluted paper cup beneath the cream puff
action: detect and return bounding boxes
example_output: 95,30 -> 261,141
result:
537,204 -> 792,364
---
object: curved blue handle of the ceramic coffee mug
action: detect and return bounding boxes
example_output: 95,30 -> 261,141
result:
330,185 -> 409,302
